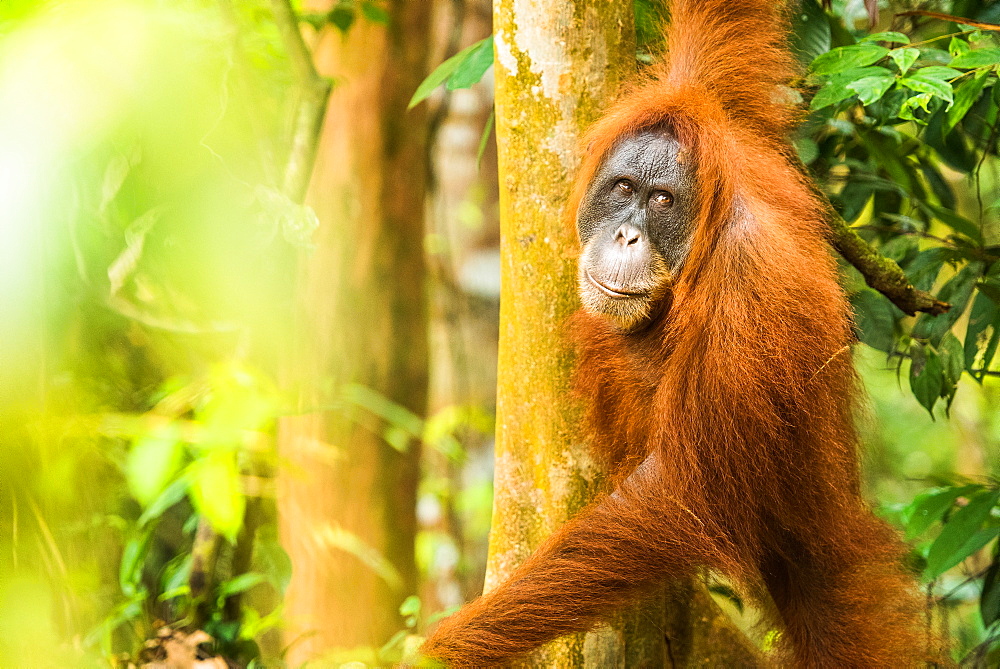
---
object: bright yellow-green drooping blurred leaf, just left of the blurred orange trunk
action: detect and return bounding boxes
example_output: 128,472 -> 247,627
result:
188,450 -> 246,541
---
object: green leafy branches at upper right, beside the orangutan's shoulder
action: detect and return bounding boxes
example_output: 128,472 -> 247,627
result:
797,7 -> 1000,415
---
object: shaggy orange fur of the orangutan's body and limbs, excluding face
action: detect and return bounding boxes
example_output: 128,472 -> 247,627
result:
424,0 -> 925,667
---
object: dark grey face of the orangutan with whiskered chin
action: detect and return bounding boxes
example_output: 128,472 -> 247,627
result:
576,128 -> 695,331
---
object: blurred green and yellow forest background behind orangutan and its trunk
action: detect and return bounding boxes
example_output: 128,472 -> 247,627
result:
0,0 -> 1000,667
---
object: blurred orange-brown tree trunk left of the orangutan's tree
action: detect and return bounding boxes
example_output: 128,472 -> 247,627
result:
279,0 -> 430,666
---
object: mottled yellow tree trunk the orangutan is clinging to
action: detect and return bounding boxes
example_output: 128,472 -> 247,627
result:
486,0 -> 757,668
